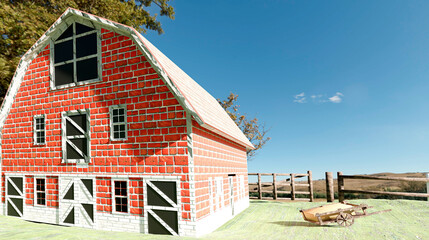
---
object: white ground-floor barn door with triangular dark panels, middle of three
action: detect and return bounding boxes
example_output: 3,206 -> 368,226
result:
59,178 -> 95,228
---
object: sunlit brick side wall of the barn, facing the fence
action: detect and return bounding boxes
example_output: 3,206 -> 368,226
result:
192,121 -> 248,219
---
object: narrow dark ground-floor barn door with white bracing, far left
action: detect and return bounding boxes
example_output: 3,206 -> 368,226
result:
6,177 -> 24,217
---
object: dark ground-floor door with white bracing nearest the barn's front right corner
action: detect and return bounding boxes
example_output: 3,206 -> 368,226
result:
146,180 -> 180,236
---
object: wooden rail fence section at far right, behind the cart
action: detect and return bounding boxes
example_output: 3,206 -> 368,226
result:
337,172 -> 429,202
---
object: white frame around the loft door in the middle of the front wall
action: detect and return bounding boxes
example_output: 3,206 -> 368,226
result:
61,109 -> 91,165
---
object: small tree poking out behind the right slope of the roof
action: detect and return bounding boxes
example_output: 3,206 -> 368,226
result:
217,93 -> 271,160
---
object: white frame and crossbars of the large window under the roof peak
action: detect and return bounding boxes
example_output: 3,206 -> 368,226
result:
49,19 -> 102,90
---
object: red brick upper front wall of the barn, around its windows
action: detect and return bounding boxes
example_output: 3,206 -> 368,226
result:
1,29 -> 189,219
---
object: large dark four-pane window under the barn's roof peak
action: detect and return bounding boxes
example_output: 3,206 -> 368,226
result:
51,22 -> 100,88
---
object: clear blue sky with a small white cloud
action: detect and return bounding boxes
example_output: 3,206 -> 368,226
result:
145,0 -> 429,178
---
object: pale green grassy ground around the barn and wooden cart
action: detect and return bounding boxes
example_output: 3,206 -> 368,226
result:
0,199 -> 429,240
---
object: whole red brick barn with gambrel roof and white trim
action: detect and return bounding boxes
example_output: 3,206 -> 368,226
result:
0,9 -> 253,236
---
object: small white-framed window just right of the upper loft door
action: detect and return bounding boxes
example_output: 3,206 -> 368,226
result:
110,105 -> 127,140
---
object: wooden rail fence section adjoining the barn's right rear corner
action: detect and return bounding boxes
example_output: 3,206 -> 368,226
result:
248,171 -> 314,202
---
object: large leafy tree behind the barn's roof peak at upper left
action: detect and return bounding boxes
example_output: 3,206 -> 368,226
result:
0,0 -> 174,102
